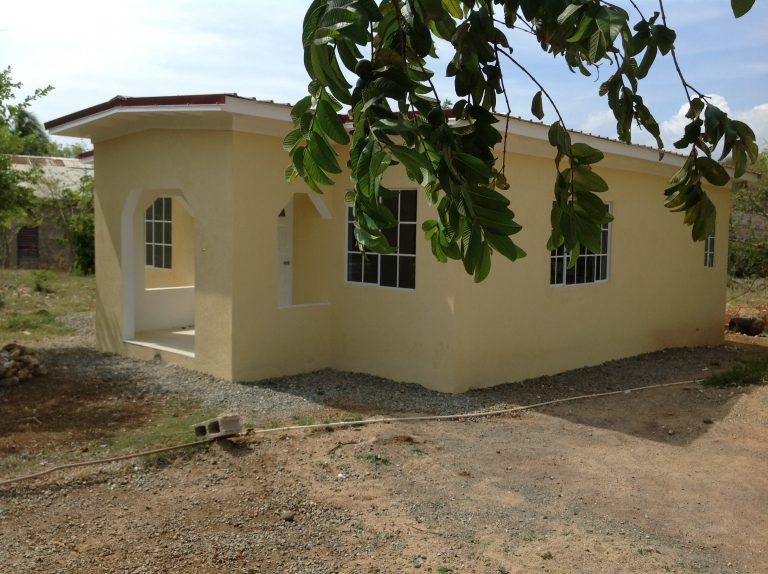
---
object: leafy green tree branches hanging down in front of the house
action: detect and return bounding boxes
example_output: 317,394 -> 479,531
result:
283,0 -> 757,281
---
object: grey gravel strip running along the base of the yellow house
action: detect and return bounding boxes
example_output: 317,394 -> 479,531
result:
30,313 -> 736,422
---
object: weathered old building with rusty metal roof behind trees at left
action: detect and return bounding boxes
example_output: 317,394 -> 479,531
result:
7,155 -> 93,270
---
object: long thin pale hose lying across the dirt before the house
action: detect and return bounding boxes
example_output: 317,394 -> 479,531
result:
0,379 -> 702,487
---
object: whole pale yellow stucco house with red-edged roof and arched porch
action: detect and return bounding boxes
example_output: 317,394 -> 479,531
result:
47,94 -> 729,392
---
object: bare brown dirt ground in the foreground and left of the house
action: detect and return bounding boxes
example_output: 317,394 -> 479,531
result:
0,344 -> 768,574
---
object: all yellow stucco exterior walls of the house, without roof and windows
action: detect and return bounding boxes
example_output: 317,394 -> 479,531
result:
91,122 -> 729,392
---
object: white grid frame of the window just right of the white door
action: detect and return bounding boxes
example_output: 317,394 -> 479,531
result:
344,188 -> 419,291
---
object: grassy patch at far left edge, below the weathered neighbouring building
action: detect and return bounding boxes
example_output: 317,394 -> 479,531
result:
0,269 -> 96,345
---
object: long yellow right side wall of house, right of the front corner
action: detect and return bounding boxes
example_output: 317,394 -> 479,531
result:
448,155 -> 729,390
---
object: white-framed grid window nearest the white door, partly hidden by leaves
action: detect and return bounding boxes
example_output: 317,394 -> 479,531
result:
347,189 -> 416,289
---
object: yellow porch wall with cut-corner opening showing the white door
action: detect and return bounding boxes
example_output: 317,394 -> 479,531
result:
232,133 -> 338,380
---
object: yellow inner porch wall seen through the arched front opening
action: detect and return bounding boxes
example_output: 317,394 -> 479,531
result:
144,197 -> 195,289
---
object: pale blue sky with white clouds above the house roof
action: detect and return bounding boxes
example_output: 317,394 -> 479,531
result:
0,0 -> 768,149
